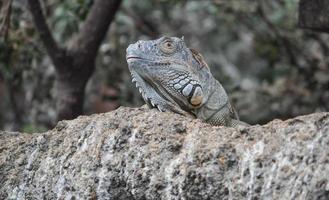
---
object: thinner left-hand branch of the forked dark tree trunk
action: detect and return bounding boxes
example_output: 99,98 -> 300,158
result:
28,0 -> 64,68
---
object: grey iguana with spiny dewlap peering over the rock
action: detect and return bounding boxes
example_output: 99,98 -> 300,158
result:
126,37 -> 247,127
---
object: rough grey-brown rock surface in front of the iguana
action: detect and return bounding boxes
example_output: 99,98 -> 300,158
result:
0,108 -> 329,200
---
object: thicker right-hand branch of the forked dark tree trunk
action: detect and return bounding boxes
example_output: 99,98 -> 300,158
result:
71,0 -> 121,59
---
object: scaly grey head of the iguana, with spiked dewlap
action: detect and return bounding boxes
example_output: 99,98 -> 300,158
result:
126,37 -> 212,111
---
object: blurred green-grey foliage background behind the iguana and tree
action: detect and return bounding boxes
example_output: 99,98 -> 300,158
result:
0,0 -> 329,132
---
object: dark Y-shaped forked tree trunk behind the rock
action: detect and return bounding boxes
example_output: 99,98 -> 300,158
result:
28,0 -> 121,120
